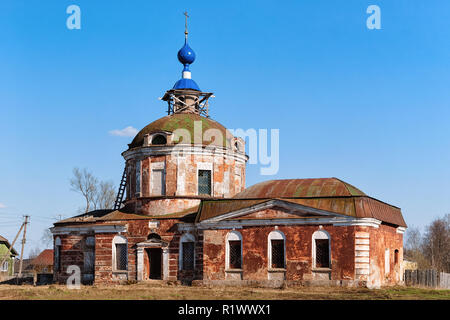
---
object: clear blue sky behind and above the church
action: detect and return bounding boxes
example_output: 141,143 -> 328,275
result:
0,0 -> 450,253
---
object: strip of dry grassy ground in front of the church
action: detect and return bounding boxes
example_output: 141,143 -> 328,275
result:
0,283 -> 450,300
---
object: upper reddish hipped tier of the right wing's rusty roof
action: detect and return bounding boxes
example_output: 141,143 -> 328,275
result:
234,178 -> 366,199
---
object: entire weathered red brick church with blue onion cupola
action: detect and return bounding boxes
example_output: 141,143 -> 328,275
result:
51,21 -> 406,288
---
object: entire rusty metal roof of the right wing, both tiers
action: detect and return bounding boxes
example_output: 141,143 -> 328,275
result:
196,178 -> 406,227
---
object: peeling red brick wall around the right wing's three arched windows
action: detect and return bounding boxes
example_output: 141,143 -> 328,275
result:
203,225 -> 355,280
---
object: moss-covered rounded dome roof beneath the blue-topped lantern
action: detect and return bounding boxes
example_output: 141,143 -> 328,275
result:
129,113 -> 233,149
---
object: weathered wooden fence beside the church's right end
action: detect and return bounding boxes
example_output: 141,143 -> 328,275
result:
404,270 -> 450,289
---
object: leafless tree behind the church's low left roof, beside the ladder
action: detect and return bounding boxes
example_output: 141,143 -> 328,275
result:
70,168 -> 116,213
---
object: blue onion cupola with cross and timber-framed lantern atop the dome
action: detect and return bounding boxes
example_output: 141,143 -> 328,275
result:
161,12 -> 214,118
